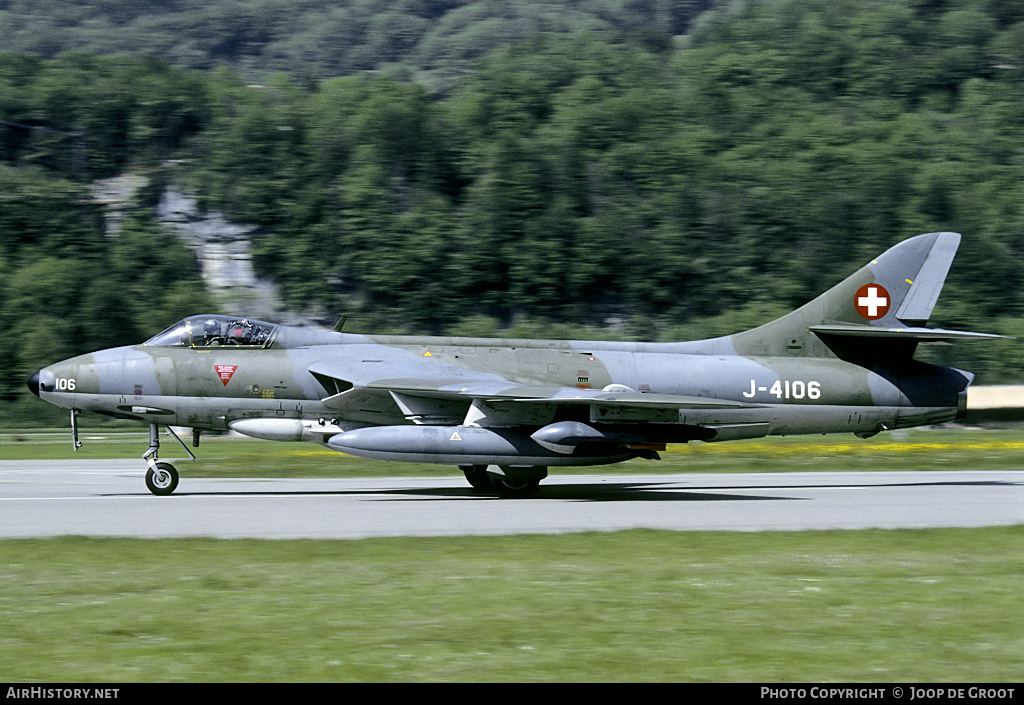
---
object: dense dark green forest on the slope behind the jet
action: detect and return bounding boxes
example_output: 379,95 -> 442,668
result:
0,0 -> 1024,422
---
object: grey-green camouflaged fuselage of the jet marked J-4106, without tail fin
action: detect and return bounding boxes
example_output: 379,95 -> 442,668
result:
30,313 -> 971,450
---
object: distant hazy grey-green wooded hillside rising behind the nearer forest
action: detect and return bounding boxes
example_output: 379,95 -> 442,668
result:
0,0 -> 712,84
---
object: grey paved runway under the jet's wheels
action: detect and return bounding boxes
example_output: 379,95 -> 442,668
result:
0,460 -> 1024,539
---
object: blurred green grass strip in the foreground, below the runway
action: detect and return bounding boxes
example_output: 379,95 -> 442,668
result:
0,527 -> 1024,682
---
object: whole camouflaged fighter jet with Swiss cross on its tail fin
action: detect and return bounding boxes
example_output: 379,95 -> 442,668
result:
29,233 -> 1000,497
